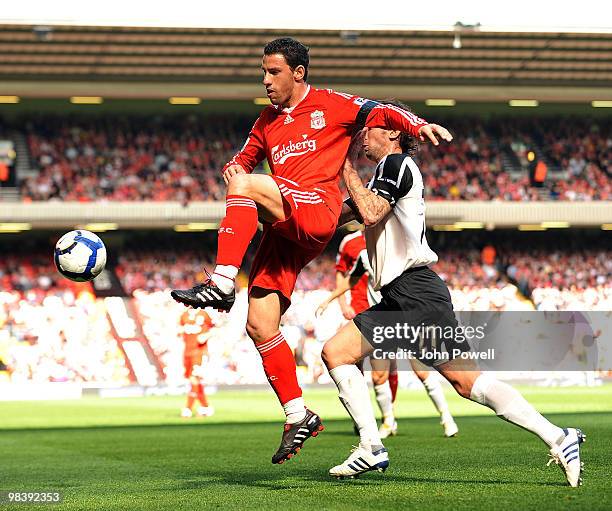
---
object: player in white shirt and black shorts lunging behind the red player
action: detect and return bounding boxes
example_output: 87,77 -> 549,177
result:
322,103 -> 585,487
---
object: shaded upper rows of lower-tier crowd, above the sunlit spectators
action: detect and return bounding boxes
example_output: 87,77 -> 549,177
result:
0,244 -> 612,305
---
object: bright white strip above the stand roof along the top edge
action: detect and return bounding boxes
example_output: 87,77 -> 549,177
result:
0,0 -> 612,33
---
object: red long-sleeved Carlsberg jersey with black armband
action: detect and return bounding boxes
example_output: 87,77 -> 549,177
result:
223,85 -> 427,215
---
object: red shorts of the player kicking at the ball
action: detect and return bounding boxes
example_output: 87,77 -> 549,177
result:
249,176 -> 338,302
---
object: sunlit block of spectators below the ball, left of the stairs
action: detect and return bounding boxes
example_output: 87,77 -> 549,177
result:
0,288 -> 129,385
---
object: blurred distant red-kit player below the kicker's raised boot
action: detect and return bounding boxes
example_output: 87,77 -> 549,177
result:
180,309 -> 214,418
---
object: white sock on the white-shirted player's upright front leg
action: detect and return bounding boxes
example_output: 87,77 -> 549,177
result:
329,364 -> 382,448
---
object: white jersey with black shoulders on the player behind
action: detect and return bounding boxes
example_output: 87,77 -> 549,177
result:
365,153 -> 438,291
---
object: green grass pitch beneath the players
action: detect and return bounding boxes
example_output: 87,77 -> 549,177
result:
0,385 -> 612,511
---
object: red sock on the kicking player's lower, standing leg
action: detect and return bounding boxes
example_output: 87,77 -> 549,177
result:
255,332 -> 302,405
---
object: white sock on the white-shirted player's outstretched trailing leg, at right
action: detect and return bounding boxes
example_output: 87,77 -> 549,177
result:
470,373 -> 565,447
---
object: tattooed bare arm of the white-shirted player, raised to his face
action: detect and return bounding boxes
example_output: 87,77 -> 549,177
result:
342,131 -> 391,227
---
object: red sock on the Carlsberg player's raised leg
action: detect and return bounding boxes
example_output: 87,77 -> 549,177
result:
217,195 -> 257,268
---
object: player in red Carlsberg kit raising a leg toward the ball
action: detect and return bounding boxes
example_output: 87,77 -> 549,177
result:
172,38 -> 452,463
